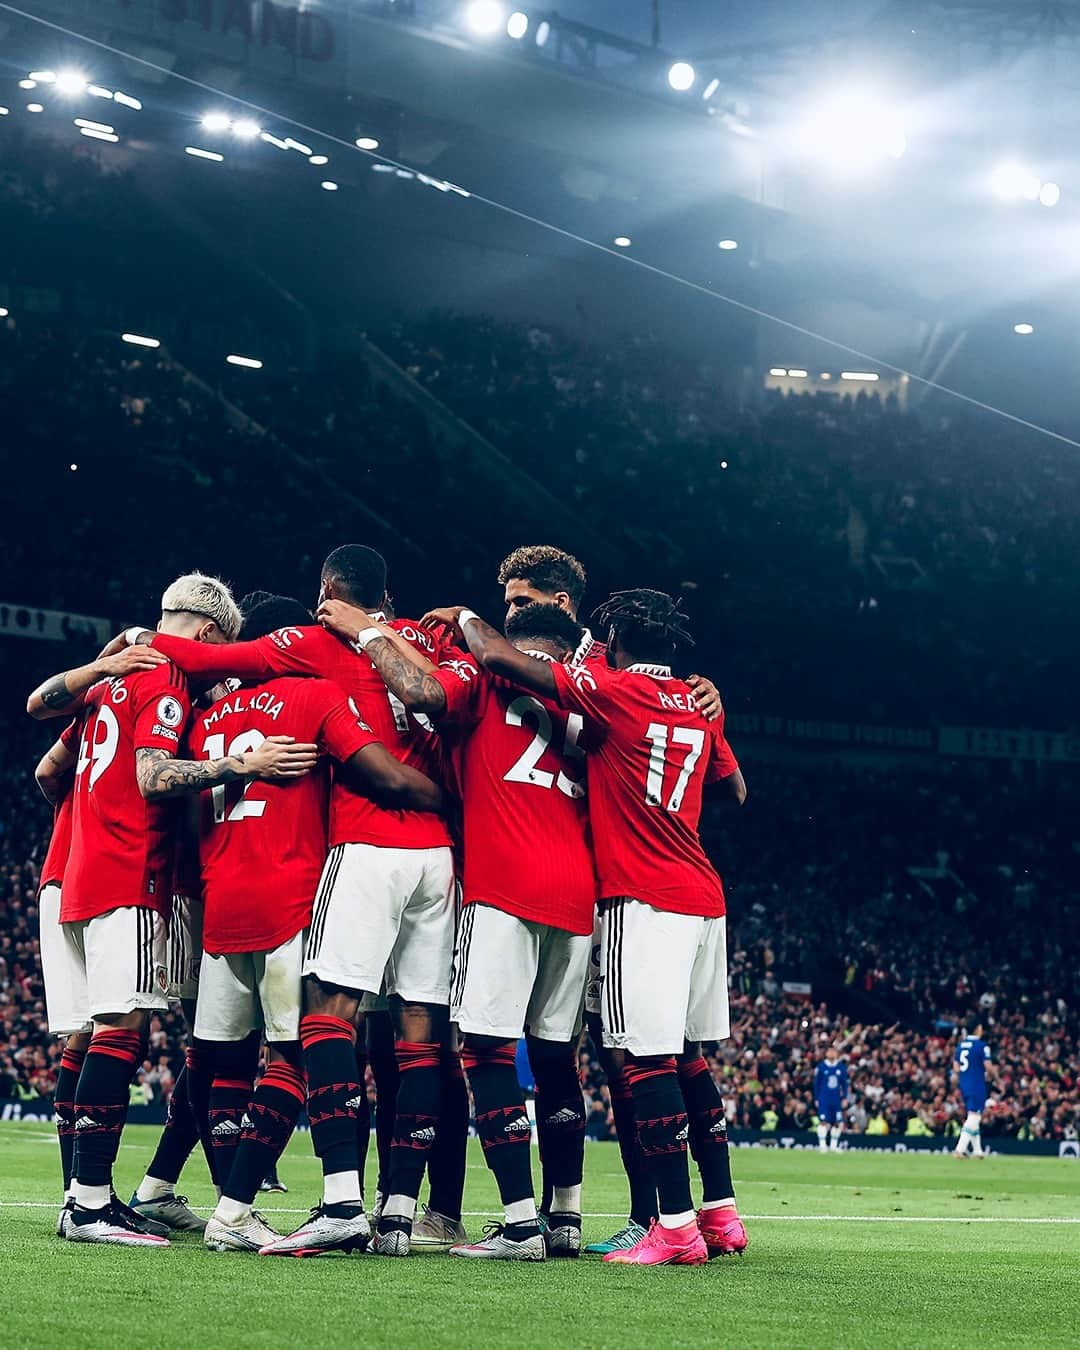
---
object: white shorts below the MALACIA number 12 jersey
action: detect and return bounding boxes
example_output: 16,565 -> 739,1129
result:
194,933 -> 304,1044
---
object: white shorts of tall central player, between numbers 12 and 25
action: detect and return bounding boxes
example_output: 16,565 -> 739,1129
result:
304,844 -> 455,1004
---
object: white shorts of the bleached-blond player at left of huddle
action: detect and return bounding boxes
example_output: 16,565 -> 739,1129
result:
50,905 -> 169,1027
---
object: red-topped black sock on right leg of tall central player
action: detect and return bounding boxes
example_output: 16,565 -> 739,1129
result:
379,1041 -> 443,1231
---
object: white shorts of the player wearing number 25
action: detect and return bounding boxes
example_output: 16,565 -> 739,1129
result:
450,902 -> 593,1041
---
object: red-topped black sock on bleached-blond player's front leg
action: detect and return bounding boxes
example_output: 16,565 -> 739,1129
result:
73,1027 -> 142,1203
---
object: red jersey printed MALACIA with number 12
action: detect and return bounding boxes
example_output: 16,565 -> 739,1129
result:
190,679 -> 377,954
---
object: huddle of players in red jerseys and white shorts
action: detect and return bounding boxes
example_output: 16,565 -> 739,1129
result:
30,545 -> 747,1265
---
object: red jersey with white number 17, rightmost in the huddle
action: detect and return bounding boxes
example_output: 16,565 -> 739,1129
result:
552,663 -> 738,915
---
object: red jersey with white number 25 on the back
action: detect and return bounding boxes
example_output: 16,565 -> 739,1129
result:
433,652 -> 597,933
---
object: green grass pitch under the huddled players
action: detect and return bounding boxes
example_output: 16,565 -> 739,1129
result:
0,1123 -> 1080,1350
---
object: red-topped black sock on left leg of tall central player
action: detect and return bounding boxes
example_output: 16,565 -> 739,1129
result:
300,1013 -> 365,1204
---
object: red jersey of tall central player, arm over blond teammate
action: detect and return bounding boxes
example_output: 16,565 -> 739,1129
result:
154,618 -> 450,848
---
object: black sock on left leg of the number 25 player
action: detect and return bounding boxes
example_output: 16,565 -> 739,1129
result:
462,1037 -> 537,1237
